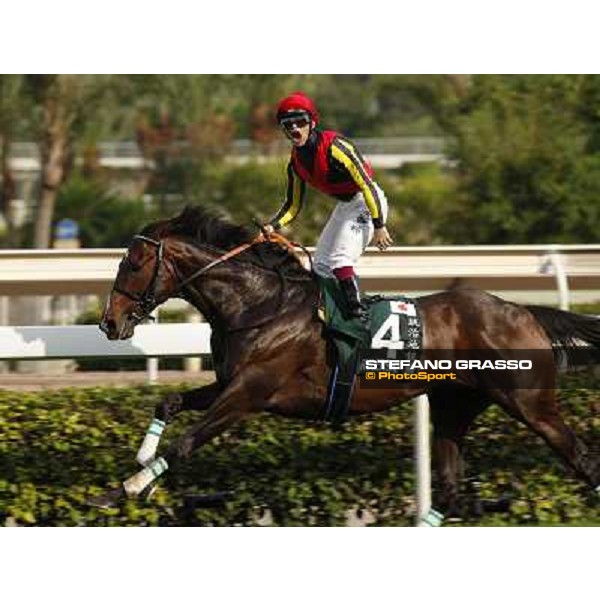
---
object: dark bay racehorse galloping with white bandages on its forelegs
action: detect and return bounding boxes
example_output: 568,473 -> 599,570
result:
97,208 -> 600,514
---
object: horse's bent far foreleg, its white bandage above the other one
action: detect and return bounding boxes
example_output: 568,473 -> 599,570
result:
136,382 -> 222,467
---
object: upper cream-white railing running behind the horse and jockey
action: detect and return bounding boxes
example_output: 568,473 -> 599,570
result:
0,244 -> 600,308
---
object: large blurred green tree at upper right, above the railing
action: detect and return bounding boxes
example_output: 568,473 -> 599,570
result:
404,75 -> 600,244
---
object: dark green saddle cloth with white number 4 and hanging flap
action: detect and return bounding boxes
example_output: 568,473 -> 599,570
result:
317,276 -> 423,424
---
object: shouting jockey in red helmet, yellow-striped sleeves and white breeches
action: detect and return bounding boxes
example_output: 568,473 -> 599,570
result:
265,92 -> 393,318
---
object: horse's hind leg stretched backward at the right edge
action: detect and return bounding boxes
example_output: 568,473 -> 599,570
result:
498,389 -> 600,491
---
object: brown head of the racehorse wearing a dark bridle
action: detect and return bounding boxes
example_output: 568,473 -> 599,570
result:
100,228 -> 177,340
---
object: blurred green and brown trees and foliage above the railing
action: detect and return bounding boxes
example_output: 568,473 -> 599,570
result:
0,75 -> 600,247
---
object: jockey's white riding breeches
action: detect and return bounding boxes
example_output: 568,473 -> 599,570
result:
313,188 -> 388,277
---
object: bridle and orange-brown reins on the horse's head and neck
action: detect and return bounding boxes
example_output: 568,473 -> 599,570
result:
112,233 -> 310,332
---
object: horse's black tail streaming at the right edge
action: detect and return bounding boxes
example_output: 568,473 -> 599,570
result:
525,305 -> 600,365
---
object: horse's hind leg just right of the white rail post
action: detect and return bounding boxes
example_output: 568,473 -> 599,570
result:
429,386 -> 490,517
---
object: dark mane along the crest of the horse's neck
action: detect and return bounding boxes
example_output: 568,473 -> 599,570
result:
142,206 -> 308,276
